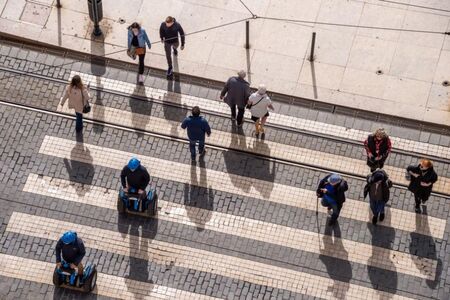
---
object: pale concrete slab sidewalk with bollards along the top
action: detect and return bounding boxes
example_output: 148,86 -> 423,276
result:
0,0 -> 450,126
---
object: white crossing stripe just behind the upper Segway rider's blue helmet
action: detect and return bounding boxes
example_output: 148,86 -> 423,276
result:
39,136 -> 446,239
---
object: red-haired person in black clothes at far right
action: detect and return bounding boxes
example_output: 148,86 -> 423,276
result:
406,159 -> 438,213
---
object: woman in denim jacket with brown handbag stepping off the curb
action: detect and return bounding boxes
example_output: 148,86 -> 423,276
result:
127,22 -> 152,83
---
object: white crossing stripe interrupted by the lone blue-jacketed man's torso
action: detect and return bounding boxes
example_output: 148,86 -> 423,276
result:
57,104 -> 450,194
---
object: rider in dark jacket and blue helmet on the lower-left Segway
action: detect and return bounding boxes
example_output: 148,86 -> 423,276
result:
55,231 -> 86,276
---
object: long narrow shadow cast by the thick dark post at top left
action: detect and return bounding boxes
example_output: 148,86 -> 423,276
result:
91,34 -> 106,134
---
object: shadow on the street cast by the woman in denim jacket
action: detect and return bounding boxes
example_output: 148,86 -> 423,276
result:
129,84 -> 153,137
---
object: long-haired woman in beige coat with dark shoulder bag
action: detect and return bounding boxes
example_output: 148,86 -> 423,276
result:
60,75 -> 91,133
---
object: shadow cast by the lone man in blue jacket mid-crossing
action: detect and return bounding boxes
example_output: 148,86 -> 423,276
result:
184,158 -> 214,231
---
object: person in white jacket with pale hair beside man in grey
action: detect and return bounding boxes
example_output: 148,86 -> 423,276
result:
247,84 -> 274,136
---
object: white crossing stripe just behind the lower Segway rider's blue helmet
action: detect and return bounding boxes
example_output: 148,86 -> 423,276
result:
6,212 -> 414,300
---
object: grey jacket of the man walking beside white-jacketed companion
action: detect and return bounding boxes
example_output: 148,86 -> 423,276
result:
220,76 -> 250,108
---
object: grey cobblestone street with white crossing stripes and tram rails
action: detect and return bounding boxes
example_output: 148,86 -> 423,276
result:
0,40 -> 450,299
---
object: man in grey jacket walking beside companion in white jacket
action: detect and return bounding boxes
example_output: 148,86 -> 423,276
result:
220,70 -> 250,127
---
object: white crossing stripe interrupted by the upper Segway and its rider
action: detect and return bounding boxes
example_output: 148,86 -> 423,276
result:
24,174 -> 437,279
